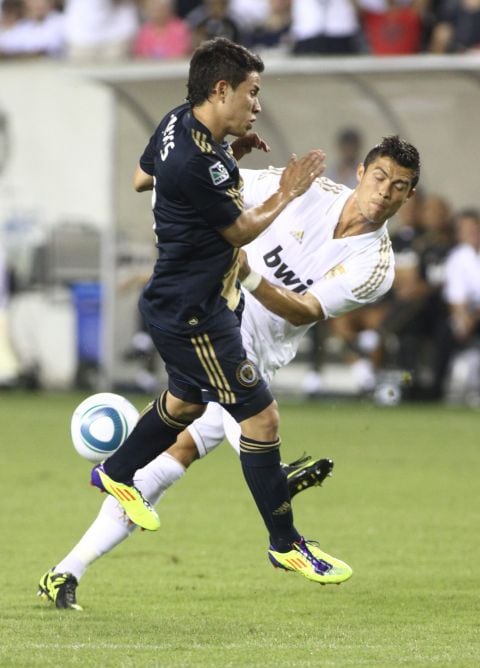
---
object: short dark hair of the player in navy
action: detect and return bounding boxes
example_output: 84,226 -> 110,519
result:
187,37 -> 265,107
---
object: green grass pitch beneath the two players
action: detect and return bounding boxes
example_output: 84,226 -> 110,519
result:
0,392 -> 480,668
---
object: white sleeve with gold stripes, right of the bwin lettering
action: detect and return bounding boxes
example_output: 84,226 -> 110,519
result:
308,246 -> 394,318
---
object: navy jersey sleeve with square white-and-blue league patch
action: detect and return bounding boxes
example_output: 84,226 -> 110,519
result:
179,154 -> 244,229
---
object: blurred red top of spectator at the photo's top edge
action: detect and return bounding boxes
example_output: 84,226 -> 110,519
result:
358,0 -> 429,56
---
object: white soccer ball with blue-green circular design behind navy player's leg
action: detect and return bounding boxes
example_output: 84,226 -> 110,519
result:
70,392 -> 138,462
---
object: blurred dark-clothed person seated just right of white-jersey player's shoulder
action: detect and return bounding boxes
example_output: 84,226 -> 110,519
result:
381,194 -> 453,399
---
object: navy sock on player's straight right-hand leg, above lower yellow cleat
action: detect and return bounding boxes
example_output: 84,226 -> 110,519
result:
240,435 -> 300,552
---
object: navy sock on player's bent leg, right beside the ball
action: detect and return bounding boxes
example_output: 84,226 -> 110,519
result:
104,392 -> 189,484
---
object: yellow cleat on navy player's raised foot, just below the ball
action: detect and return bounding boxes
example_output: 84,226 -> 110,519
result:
91,464 -> 160,531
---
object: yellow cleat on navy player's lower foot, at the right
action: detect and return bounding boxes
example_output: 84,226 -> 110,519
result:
268,538 -> 353,584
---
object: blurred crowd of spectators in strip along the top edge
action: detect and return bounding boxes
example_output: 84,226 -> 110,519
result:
0,0 -> 480,63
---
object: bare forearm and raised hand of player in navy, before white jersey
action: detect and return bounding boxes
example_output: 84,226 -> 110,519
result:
220,149 -> 325,248
